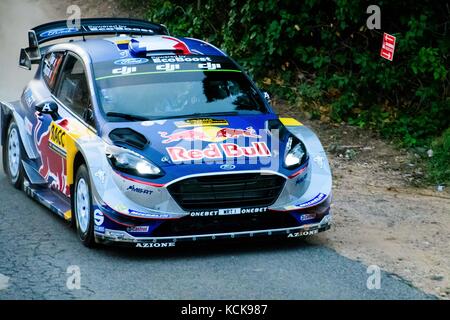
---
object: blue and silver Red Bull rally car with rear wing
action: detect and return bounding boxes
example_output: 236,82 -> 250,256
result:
0,18 -> 332,248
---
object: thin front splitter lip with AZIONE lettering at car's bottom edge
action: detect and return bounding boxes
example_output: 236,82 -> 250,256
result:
95,211 -> 331,248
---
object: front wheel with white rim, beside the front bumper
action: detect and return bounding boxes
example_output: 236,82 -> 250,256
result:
72,164 -> 95,248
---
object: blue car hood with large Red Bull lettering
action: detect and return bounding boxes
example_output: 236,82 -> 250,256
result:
102,114 -> 294,178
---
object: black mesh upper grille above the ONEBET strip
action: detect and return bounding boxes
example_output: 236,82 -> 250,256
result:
168,173 -> 285,211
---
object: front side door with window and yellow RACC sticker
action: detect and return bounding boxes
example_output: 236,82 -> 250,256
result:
36,52 -> 93,197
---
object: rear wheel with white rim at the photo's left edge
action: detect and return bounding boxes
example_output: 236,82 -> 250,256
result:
3,120 -> 24,189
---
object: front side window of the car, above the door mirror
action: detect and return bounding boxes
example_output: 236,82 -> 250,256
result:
56,54 -> 92,124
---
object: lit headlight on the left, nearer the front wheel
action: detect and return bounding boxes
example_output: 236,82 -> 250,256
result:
106,146 -> 162,178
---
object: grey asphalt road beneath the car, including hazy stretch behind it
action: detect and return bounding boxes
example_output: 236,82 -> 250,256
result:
0,0 -> 430,299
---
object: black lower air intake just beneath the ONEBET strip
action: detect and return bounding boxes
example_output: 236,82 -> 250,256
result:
152,212 -> 300,237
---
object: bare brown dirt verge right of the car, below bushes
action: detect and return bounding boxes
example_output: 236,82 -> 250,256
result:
274,101 -> 450,299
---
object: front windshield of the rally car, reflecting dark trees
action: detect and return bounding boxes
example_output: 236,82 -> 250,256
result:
92,60 -> 267,121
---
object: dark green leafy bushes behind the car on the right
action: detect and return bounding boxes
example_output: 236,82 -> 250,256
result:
124,0 -> 450,183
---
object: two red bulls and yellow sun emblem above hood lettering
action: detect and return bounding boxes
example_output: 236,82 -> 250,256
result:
159,126 -> 261,143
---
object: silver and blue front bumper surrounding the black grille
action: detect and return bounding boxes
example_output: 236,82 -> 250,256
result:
82,122 -> 332,247
